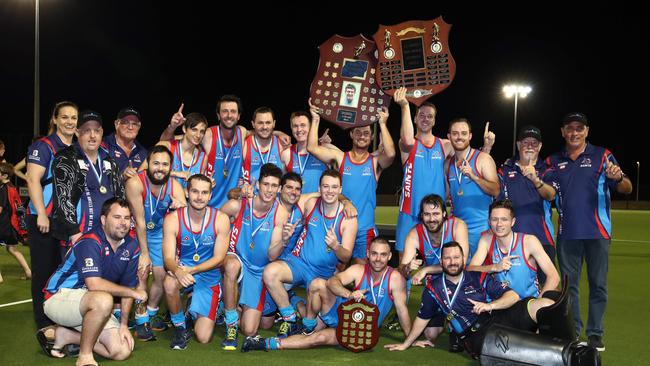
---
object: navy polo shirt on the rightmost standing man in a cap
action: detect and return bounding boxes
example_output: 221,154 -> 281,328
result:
546,143 -> 618,240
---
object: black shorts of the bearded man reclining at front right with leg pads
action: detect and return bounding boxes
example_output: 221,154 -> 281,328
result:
461,297 -> 537,358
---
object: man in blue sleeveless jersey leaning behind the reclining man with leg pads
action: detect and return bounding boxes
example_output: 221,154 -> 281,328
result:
467,200 -> 560,298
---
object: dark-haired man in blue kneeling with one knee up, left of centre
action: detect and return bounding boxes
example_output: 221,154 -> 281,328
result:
221,163 -> 288,351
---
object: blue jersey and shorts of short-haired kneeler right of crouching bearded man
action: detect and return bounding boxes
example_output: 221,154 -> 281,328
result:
176,207 -> 221,320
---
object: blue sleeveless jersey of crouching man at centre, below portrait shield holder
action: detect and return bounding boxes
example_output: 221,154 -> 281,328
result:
292,198 -> 345,278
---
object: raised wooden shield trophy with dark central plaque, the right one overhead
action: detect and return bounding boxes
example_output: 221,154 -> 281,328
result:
374,16 -> 456,106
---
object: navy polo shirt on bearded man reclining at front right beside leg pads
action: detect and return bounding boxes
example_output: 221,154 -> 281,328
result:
418,271 -> 510,334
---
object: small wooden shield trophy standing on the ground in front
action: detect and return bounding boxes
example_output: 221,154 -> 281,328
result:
336,299 -> 379,353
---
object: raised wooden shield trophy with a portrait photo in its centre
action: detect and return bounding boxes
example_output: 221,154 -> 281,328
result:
309,34 -> 390,129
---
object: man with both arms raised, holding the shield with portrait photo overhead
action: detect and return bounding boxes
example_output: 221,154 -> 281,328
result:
307,101 -> 395,263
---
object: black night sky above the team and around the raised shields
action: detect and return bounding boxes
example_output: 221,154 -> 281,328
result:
0,0 -> 650,199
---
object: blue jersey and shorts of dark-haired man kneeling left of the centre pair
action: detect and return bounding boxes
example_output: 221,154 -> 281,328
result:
228,198 -> 279,314
